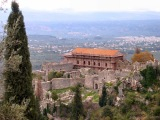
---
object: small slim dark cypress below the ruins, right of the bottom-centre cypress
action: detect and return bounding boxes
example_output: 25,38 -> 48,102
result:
99,85 -> 107,107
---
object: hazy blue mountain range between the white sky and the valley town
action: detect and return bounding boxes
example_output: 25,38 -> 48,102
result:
0,11 -> 160,38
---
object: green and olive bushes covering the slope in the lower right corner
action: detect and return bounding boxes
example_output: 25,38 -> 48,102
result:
90,66 -> 160,120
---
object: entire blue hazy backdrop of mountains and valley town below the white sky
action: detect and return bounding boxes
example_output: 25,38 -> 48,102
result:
1,11 -> 160,69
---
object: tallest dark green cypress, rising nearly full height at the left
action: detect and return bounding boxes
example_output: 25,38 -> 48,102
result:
3,1 -> 39,120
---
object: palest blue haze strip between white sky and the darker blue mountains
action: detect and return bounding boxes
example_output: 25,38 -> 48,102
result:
20,12 -> 160,22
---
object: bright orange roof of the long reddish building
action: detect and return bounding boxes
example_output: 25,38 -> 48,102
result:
72,48 -> 122,56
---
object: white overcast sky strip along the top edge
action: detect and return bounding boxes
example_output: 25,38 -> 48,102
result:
0,0 -> 160,12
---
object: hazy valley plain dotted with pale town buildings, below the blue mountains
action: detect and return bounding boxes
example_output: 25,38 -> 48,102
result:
29,35 -> 160,69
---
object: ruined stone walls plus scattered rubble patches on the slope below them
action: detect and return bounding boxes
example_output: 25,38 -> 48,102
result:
32,61 -> 160,119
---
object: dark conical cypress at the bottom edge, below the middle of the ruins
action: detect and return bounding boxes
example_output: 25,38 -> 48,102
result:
71,84 -> 84,120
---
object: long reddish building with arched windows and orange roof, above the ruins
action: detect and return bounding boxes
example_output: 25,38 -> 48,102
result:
64,48 -> 124,70
